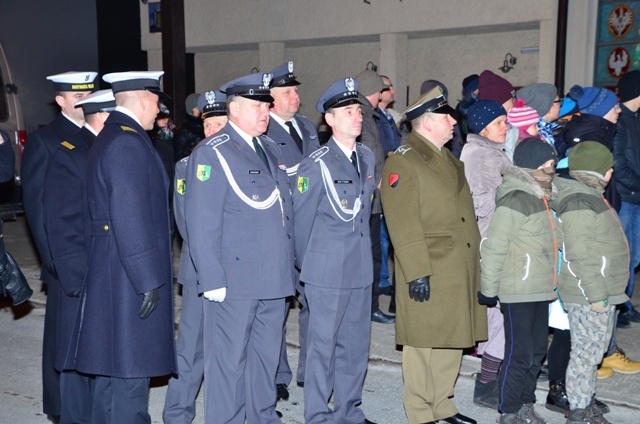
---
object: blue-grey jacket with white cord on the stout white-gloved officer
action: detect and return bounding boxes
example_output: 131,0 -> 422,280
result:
185,123 -> 295,299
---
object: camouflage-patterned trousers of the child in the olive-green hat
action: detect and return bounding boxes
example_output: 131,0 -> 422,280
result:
564,303 -> 615,410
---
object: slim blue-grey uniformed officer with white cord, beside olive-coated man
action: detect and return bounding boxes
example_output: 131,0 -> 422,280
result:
293,78 -> 376,424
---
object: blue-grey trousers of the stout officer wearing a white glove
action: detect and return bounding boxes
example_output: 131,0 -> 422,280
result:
203,298 -> 285,424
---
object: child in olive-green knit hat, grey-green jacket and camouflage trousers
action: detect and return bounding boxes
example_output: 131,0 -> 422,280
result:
554,141 -> 629,424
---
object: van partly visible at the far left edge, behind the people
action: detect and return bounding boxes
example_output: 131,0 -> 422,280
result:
0,39 -> 27,219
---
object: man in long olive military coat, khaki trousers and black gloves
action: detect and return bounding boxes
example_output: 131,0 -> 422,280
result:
381,87 -> 487,424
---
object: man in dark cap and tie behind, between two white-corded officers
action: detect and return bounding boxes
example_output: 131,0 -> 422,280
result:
267,61 -> 320,400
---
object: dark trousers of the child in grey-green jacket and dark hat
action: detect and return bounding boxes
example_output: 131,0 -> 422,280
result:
498,302 -> 549,414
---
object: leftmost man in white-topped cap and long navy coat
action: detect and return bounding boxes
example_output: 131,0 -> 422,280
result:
20,72 -> 98,420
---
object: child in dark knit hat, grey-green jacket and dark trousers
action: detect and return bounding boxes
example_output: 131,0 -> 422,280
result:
478,138 -> 557,424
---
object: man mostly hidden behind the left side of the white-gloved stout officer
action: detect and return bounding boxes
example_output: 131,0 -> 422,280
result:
162,90 -> 227,424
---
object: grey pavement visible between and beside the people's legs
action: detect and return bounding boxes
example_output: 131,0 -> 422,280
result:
0,217 -> 640,424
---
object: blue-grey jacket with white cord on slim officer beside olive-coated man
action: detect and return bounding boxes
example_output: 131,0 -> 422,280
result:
293,137 -> 376,289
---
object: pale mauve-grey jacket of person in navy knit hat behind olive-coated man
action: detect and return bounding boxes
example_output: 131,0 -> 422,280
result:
460,134 -> 511,237
